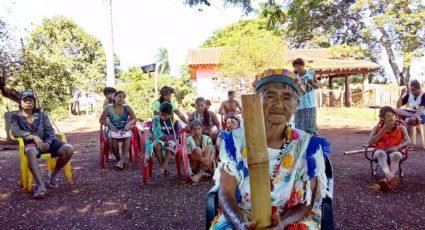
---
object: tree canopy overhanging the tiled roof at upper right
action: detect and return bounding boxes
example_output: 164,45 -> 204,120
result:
261,0 -> 425,84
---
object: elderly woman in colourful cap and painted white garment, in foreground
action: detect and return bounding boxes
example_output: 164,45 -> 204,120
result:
213,69 -> 330,229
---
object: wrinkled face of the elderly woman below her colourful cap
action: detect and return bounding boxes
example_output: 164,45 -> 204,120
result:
261,84 -> 298,125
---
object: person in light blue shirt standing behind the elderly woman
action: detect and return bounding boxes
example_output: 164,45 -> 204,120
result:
292,58 -> 320,133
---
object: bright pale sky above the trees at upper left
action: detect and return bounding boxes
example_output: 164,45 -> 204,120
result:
0,0 -> 250,75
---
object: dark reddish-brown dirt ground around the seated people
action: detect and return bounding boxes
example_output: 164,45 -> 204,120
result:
0,116 -> 425,229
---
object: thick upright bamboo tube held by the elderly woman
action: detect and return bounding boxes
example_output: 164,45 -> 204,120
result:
242,94 -> 272,229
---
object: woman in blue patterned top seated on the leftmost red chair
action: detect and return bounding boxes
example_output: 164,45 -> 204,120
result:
99,91 -> 137,170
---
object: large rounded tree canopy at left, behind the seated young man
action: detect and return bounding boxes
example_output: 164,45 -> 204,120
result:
10,16 -> 106,110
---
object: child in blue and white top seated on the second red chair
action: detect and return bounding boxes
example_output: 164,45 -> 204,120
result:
151,102 -> 180,175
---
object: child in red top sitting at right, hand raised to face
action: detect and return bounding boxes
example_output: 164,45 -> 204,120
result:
369,106 -> 410,191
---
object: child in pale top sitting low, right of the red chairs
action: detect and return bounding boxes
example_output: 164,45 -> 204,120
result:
187,119 -> 215,183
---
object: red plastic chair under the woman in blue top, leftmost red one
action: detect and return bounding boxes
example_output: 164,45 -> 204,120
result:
99,125 -> 139,168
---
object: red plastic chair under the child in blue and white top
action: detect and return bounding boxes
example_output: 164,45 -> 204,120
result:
140,121 -> 190,185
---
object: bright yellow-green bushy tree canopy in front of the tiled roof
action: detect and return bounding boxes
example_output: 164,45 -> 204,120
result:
203,19 -> 286,83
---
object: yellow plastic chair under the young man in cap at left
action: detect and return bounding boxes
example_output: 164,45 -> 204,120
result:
10,134 -> 72,192
